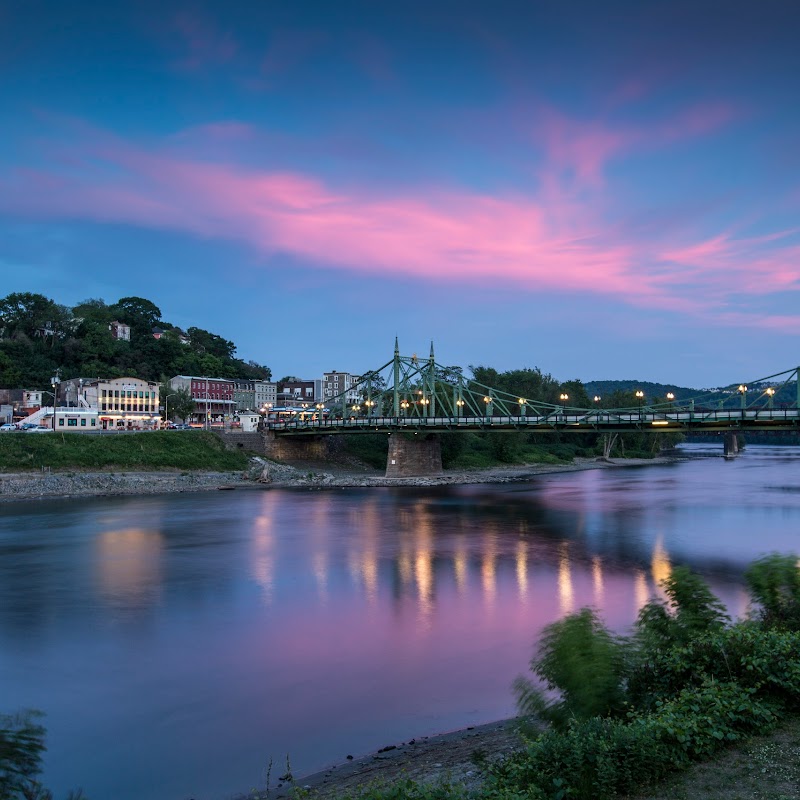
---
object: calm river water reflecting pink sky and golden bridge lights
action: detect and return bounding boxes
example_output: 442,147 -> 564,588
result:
0,444 -> 800,800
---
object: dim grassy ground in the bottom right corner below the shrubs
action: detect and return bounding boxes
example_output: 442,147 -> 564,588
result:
628,716 -> 800,800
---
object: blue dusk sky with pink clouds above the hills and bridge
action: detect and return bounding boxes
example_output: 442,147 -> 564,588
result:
0,0 -> 800,387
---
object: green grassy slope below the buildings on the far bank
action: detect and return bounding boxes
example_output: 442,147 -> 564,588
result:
0,431 -> 247,472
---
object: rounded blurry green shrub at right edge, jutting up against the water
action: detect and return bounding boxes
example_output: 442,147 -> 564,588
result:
745,553 -> 800,631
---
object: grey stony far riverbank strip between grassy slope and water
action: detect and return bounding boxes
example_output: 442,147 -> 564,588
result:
0,455 -> 679,500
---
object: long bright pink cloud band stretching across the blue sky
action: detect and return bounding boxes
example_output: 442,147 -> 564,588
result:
0,113 -> 800,325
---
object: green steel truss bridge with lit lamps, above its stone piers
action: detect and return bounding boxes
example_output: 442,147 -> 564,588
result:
268,340 -> 800,437
